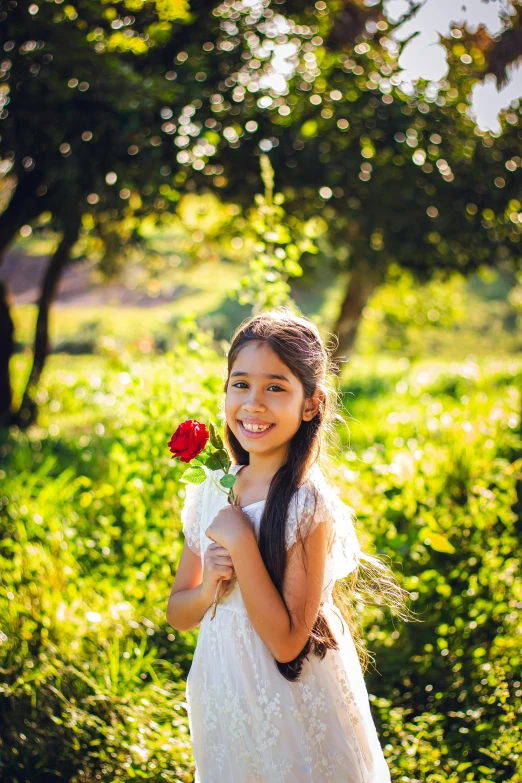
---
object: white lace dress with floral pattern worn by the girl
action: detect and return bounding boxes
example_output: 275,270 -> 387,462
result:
181,465 -> 390,783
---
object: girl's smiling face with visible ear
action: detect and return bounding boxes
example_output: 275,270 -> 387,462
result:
225,340 -> 318,454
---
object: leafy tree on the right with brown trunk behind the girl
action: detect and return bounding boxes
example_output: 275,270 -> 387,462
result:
166,3 -> 521,355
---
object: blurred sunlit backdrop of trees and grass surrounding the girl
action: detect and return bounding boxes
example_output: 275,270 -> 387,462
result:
0,0 -> 522,783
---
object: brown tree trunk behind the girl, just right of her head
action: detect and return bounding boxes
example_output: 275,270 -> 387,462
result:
333,260 -> 384,361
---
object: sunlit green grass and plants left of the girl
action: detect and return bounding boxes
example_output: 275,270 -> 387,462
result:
0,346 -> 220,783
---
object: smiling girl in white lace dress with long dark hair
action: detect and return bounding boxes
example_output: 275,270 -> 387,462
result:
167,308 -> 406,783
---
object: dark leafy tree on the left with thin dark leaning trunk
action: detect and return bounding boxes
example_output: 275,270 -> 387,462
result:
0,0 -> 213,425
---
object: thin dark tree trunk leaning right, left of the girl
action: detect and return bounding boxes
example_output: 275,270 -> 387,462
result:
15,215 -> 81,428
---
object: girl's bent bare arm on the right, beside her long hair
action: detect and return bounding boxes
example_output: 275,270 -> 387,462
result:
226,524 -> 329,663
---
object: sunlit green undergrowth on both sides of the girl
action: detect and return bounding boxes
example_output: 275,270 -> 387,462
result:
0,338 -> 522,783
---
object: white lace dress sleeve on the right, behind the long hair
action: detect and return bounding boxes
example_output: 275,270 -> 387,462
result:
286,474 -> 361,580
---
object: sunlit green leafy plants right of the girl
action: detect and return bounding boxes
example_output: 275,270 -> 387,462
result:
340,359 -> 522,783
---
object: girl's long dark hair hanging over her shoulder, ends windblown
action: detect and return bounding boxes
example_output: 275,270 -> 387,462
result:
219,307 -> 406,681
